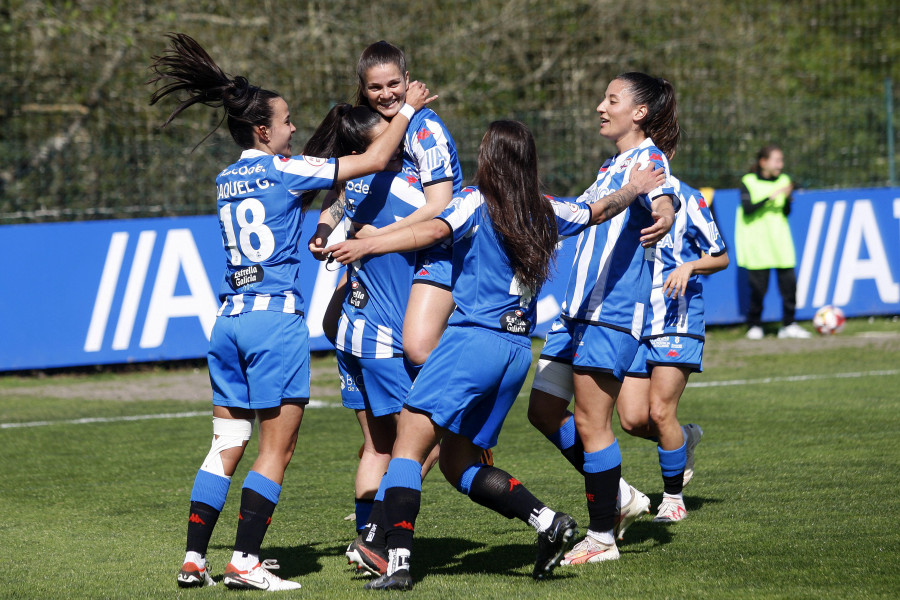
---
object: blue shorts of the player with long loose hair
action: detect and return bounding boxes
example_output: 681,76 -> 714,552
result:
406,326 -> 531,448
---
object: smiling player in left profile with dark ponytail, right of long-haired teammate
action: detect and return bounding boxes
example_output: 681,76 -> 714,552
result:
524,73 -> 680,564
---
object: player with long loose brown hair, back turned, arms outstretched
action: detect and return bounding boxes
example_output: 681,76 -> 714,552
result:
327,121 -> 662,589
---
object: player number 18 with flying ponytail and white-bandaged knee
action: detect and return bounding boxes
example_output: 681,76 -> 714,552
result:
150,34 -> 428,590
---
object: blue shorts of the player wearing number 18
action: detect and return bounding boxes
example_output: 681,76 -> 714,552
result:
207,310 -> 309,410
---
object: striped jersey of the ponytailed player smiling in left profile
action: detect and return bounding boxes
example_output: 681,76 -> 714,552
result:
562,138 -> 678,338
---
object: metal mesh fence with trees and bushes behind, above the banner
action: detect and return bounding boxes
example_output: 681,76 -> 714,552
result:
0,0 -> 900,223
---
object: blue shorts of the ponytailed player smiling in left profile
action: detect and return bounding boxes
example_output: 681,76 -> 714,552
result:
572,323 -> 641,381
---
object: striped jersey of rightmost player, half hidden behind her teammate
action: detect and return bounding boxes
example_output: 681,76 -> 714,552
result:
644,177 -> 725,339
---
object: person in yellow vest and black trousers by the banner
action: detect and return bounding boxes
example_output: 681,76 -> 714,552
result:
735,145 -> 811,340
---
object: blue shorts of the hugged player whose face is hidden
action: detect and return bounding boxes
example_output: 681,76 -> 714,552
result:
337,350 -> 413,417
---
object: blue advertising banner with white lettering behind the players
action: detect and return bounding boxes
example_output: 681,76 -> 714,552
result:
0,189 -> 900,371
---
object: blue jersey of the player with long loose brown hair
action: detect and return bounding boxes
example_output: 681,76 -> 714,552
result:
437,187 -> 591,335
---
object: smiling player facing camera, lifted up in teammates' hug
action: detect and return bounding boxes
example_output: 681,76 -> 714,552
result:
310,41 -> 463,368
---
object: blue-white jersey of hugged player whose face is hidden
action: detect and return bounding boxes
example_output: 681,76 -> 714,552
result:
335,171 -> 425,358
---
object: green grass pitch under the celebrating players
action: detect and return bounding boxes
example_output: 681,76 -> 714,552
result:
0,320 -> 900,599
